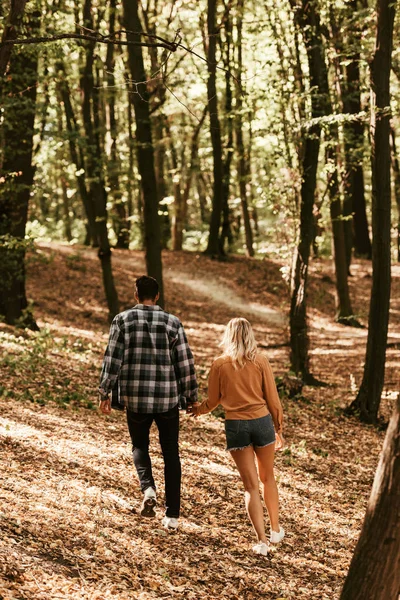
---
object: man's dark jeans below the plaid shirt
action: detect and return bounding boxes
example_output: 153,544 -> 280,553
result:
126,406 -> 181,518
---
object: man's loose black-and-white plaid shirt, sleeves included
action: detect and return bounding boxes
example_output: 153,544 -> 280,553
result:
99,304 -> 198,413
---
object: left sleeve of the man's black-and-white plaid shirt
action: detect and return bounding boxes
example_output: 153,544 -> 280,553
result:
99,315 -> 125,398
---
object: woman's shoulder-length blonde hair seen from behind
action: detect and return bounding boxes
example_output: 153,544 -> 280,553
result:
221,317 -> 257,369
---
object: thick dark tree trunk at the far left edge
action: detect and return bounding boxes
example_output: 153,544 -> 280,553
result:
0,8 -> 40,330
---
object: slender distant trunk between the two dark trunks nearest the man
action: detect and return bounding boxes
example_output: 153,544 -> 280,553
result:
106,0 -> 129,249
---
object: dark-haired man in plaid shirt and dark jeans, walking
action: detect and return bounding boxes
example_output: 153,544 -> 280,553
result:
99,275 -> 198,529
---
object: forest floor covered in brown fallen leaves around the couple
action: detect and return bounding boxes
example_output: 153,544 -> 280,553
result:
0,244 -> 400,600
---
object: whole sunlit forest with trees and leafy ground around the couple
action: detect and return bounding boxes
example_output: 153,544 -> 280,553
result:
0,0 -> 400,600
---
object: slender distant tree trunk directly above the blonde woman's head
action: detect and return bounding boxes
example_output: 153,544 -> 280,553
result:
235,0 -> 254,256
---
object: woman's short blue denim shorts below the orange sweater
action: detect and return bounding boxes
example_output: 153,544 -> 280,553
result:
225,415 -> 275,450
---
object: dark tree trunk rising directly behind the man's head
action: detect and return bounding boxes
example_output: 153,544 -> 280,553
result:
123,0 -> 164,306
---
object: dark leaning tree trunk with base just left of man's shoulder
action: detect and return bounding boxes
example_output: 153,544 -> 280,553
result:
81,0 -> 119,320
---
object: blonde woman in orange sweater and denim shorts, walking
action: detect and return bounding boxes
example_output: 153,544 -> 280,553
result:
193,319 -> 285,556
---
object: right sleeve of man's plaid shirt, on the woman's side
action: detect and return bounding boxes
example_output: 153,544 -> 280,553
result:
173,324 -> 198,403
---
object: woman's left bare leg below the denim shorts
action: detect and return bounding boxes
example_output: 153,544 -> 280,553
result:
231,446 -> 267,543
